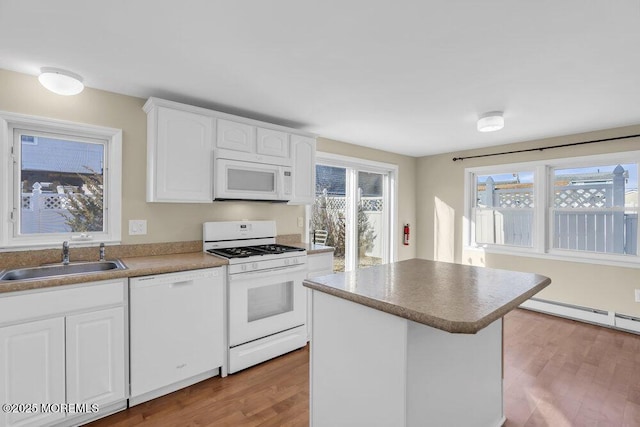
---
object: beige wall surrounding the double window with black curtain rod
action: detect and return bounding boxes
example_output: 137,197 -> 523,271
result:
416,126 -> 640,316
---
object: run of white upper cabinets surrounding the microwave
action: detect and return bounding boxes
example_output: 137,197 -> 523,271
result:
143,98 -> 316,204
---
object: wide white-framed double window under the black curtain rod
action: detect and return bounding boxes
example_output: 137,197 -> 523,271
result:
465,152 -> 640,264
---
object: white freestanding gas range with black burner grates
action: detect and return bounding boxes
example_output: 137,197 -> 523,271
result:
203,221 -> 307,373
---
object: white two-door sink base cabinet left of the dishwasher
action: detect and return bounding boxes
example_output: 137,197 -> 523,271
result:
0,280 -> 128,427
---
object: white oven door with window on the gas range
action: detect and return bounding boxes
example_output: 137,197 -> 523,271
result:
228,264 -> 307,347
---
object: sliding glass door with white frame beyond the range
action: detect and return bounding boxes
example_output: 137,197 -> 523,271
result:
310,153 -> 397,271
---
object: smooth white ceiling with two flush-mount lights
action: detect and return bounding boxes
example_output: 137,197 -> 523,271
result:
0,0 -> 640,156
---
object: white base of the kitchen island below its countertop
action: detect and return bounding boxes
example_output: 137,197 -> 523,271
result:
309,291 -> 504,427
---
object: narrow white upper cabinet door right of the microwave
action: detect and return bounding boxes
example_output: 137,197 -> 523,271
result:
289,135 -> 316,205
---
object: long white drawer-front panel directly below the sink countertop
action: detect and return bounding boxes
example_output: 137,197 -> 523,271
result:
0,280 -> 125,325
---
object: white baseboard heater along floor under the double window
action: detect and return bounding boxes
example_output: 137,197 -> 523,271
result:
520,298 -> 640,334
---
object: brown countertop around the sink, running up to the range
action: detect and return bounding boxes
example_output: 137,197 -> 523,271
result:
0,252 -> 228,294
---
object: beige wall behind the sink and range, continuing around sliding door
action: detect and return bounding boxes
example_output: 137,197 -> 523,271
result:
0,69 -> 415,257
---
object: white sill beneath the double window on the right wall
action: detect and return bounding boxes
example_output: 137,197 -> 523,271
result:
463,245 -> 640,268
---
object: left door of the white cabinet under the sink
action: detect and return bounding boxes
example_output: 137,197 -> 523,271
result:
0,317 -> 66,426
